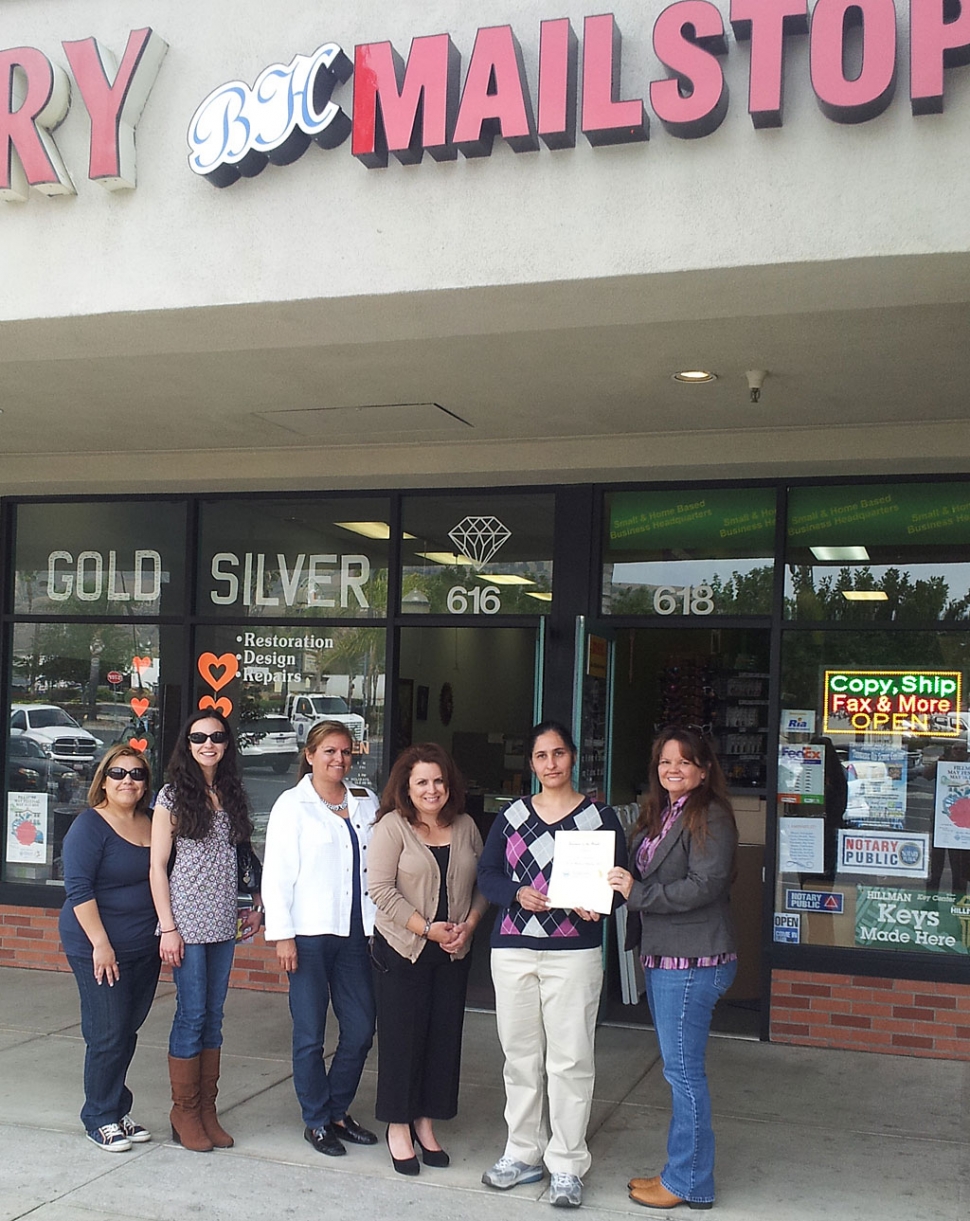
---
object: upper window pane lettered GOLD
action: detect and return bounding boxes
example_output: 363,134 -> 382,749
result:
13,501 -> 186,618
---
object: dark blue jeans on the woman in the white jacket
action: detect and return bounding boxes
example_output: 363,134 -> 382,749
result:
290,927 -> 374,1128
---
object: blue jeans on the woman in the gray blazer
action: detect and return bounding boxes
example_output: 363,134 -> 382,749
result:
645,962 -> 738,1204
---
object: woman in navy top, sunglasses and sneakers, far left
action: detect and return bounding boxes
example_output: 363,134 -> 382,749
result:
59,744 -> 161,1153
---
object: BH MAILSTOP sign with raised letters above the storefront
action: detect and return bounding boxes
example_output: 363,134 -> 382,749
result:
188,0 -> 970,187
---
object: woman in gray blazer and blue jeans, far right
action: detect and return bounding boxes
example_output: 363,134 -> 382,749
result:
608,725 -> 738,1209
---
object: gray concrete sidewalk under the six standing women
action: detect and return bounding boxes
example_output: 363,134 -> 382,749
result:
0,968 -> 970,1221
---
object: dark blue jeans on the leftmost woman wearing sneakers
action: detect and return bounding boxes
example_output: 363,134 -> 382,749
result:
67,950 -> 161,1132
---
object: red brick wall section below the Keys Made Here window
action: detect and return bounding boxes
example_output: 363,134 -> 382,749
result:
771,971 -> 970,1060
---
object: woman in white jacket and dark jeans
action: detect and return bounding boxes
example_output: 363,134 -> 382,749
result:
263,720 -> 377,1158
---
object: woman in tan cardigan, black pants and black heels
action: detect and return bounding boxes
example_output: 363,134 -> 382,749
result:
368,742 -> 487,1175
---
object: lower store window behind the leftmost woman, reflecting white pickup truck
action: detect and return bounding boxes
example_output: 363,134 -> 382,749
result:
4,621 -> 180,885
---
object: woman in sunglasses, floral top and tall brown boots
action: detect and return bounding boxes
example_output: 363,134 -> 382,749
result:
151,711 -> 263,1153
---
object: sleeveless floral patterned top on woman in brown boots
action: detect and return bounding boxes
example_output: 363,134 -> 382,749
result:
155,784 -> 238,945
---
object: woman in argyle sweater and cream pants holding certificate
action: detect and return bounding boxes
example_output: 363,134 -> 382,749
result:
479,720 -> 627,1208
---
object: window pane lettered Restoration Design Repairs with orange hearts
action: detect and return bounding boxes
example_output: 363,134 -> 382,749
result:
193,621 -> 386,852
